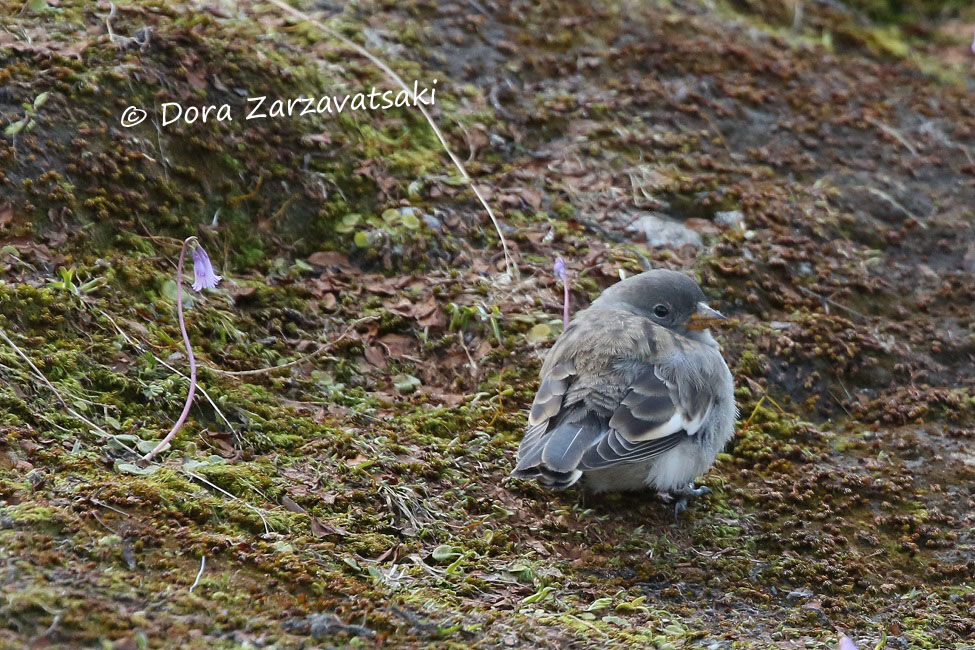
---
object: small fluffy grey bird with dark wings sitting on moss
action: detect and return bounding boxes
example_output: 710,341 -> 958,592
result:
512,269 -> 738,515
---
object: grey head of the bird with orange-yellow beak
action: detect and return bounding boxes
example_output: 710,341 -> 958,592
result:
593,269 -> 728,338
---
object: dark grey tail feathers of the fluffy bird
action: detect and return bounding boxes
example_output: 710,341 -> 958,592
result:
511,409 -> 606,490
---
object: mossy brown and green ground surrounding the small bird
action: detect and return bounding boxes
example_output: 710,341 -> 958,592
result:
0,0 -> 975,648
